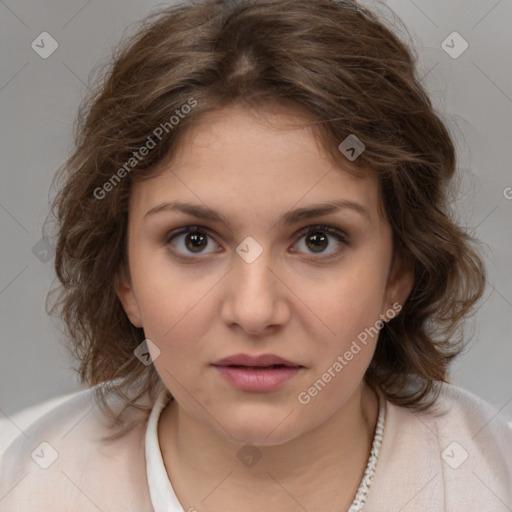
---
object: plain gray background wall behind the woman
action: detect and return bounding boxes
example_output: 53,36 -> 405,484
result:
0,0 -> 512,419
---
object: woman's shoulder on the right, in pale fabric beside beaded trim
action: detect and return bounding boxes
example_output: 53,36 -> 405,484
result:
369,384 -> 512,512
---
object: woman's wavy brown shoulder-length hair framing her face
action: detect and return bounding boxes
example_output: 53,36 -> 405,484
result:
49,0 -> 485,436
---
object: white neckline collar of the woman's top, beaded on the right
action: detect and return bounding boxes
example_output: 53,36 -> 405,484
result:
145,388 -> 386,512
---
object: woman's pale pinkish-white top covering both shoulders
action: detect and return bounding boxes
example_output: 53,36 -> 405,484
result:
0,385 -> 512,512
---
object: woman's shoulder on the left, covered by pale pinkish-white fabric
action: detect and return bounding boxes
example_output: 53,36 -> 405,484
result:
0,385 -> 156,512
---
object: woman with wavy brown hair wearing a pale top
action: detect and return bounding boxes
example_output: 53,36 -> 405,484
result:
0,0 -> 512,512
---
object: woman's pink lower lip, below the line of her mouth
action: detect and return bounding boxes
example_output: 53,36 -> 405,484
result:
211,366 -> 301,392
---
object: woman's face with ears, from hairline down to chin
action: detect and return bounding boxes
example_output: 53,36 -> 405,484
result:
118,107 -> 411,445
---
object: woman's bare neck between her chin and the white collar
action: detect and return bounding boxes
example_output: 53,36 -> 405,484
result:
158,384 -> 378,512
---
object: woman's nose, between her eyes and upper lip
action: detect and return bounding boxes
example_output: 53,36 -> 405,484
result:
221,250 -> 290,335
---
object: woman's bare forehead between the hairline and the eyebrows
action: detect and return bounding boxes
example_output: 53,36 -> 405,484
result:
131,106 -> 379,224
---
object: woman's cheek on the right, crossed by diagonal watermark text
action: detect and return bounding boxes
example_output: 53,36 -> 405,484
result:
299,251 -> 387,386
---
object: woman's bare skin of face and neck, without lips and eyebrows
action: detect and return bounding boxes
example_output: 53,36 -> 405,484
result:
117,106 -> 412,512
